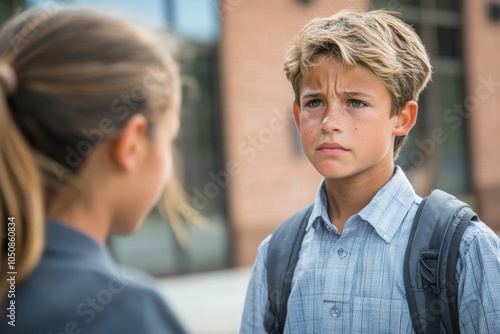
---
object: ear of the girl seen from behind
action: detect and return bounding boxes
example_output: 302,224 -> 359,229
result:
111,114 -> 148,172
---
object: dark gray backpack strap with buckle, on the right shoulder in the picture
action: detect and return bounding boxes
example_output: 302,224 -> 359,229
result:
403,190 -> 477,334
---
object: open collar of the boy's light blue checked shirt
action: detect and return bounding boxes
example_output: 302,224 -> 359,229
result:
306,166 -> 421,243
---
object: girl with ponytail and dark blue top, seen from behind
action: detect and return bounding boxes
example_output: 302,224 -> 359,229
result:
0,7 -> 188,334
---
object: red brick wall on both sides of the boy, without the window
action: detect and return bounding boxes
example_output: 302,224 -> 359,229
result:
220,0 -> 500,265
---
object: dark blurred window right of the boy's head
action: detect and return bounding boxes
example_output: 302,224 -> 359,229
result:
373,0 -> 470,196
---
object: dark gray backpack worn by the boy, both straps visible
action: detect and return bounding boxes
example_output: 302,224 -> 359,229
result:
264,190 -> 478,334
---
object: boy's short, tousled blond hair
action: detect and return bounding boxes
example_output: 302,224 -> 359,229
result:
284,10 -> 432,157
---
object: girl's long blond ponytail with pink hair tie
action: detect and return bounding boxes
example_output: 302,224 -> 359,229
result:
0,63 -> 45,300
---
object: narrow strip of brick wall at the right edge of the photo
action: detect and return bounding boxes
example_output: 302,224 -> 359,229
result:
462,0 -> 500,231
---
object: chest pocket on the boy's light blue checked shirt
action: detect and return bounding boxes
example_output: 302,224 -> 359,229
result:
352,297 -> 414,334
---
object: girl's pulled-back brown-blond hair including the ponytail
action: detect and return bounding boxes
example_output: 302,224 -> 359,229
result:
0,7 -> 180,299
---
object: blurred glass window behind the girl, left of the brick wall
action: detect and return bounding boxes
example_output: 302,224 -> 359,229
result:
26,0 -> 229,275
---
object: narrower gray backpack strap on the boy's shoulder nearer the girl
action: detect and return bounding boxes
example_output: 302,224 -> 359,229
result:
264,204 -> 313,333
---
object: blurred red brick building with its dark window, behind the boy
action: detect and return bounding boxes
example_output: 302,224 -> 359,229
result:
220,0 -> 500,265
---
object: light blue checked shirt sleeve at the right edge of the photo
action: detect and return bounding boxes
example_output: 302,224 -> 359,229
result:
457,222 -> 500,333
